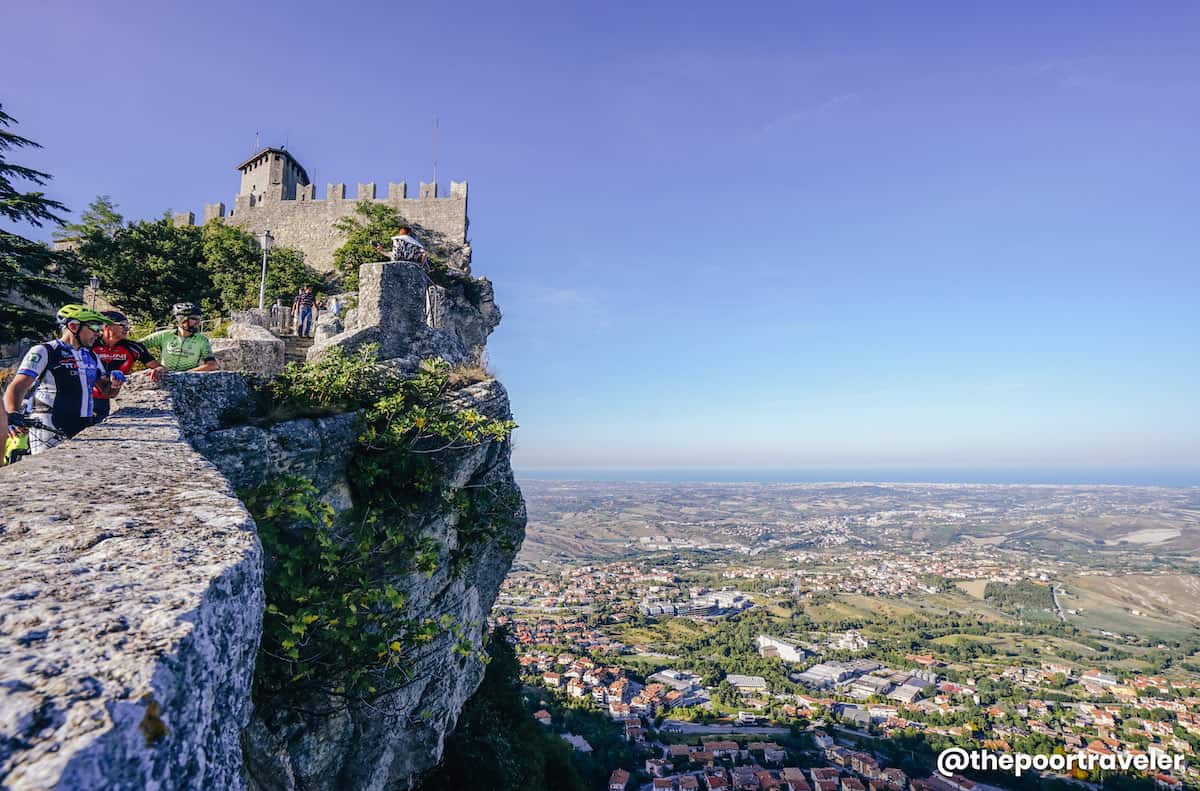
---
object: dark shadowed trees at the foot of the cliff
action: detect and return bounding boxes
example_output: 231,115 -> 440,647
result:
419,627 -> 588,791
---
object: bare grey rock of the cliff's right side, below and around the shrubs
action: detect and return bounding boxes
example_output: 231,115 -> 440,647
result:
245,380 -> 526,790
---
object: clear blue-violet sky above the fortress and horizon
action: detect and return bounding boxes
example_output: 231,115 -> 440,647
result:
9,0 -> 1200,483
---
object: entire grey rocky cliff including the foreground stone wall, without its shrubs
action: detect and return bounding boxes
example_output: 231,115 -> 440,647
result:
0,263 -> 524,790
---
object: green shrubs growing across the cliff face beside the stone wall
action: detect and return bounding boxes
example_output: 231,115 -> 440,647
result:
242,347 -> 518,699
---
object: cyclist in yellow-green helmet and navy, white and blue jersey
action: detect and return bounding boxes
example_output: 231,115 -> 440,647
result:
4,305 -> 121,454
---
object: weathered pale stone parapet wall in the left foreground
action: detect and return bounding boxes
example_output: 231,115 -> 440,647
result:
0,374 -> 263,789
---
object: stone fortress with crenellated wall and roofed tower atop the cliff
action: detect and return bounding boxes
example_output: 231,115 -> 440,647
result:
192,148 -> 469,271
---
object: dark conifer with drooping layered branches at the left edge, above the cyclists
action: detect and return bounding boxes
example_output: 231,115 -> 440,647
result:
0,104 -> 85,338
